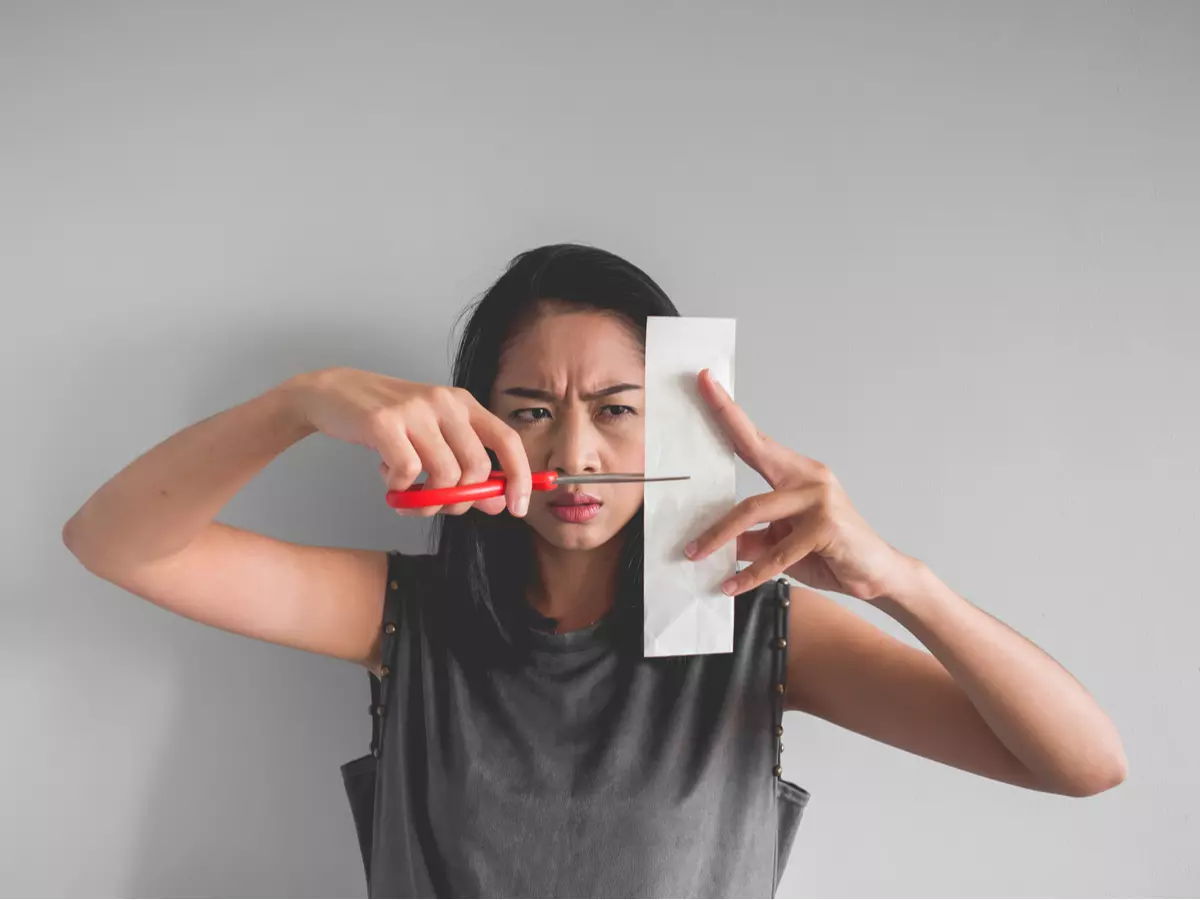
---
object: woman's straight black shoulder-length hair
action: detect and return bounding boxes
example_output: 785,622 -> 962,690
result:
434,244 -> 679,653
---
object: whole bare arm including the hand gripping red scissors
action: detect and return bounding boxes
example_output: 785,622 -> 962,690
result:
62,368 -> 529,667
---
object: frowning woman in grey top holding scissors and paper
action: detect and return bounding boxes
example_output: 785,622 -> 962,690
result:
64,245 -> 1126,896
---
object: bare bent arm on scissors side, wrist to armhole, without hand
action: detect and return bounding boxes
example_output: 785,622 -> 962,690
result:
62,374 -> 386,665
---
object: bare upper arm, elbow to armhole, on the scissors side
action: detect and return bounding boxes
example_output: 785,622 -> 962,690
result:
97,522 -> 388,667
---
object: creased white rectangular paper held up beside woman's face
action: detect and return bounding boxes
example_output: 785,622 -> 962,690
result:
643,316 -> 737,656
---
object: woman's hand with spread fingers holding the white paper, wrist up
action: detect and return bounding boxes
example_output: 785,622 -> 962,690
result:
688,370 -> 914,601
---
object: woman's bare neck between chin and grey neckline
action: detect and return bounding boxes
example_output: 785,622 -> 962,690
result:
529,535 -> 624,631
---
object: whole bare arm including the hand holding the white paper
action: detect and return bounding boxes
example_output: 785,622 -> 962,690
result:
689,373 -> 1127,797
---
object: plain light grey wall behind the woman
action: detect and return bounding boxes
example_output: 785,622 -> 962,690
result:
0,1 -> 1200,896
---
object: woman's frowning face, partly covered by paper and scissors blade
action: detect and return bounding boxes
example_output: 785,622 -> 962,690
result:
491,307 -> 646,550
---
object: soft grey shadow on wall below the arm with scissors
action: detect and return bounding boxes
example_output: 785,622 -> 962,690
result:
126,632 -> 370,896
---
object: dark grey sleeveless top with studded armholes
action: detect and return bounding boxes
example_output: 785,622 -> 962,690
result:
342,553 -> 808,898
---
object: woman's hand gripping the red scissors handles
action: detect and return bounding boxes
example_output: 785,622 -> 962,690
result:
289,367 -> 532,516
